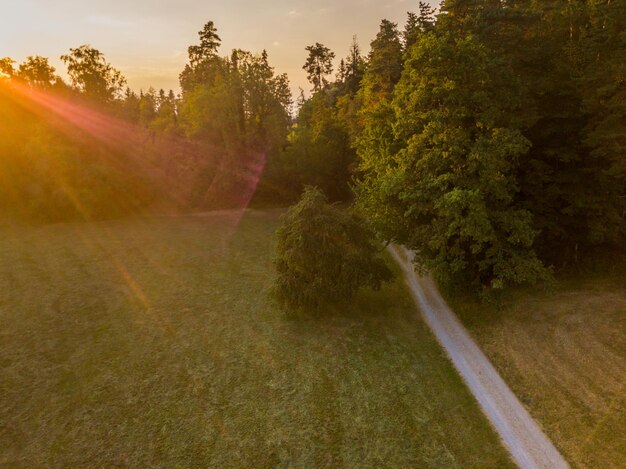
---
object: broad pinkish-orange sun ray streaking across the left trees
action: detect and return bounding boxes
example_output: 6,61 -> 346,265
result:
0,81 -> 266,223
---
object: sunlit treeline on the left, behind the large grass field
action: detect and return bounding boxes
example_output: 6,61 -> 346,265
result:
0,22 -> 291,221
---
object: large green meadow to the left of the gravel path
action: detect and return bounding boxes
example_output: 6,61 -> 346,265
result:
0,212 -> 512,468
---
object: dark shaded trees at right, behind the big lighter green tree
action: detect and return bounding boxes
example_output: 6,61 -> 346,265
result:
438,0 -> 626,267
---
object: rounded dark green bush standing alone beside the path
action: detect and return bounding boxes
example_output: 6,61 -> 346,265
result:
272,187 -> 393,312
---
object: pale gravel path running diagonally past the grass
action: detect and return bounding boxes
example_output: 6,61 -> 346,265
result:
389,246 -> 569,469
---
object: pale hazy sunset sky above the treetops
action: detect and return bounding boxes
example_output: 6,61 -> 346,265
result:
0,0 -> 438,94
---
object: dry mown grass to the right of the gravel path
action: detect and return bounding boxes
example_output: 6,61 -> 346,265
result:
450,274 -> 626,469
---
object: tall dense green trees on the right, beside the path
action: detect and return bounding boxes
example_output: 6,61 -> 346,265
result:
279,0 -> 626,290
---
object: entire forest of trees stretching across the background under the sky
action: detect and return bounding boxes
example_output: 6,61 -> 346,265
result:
0,0 -> 626,291
